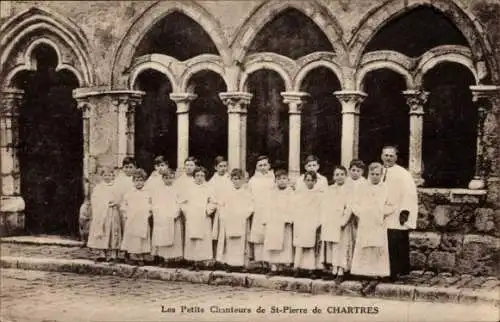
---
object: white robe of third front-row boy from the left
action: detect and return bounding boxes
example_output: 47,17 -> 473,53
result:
151,184 -> 184,259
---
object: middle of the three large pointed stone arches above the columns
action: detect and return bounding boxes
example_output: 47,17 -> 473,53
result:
231,0 -> 346,62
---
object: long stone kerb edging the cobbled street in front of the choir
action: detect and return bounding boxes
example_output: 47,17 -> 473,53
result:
0,256 -> 500,307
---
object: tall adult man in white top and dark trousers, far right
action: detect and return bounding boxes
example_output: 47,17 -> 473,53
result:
381,146 -> 418,279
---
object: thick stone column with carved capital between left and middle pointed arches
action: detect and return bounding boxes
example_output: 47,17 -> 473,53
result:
219,92 -> 253,169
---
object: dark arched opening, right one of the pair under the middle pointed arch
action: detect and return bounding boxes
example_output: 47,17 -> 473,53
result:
300,67 -> 342,179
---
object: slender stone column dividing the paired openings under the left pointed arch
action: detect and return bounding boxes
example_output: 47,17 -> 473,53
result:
170,93 -> 198,169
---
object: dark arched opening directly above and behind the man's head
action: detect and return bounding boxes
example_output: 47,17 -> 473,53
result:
359,69 -> 410,167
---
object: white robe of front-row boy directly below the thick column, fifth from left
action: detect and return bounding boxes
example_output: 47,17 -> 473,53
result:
216,187 -> 254,266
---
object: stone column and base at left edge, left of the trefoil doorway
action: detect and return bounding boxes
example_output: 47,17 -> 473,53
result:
0,88 -> 25,236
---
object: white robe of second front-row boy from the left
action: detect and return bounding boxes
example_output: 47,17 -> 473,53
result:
121,188 -> 152,254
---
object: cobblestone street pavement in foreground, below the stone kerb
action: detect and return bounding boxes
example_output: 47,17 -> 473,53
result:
0,269 -> 498,322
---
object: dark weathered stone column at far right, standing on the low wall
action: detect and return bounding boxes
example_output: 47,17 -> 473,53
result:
469,85 -> 499,190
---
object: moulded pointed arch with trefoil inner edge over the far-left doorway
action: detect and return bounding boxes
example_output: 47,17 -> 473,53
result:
0,8 -> 95,87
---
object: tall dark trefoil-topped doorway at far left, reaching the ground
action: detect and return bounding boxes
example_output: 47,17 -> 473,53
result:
15,45 -> 83,236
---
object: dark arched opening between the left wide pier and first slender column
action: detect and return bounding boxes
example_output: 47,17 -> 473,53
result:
135,70 -> 177,173
